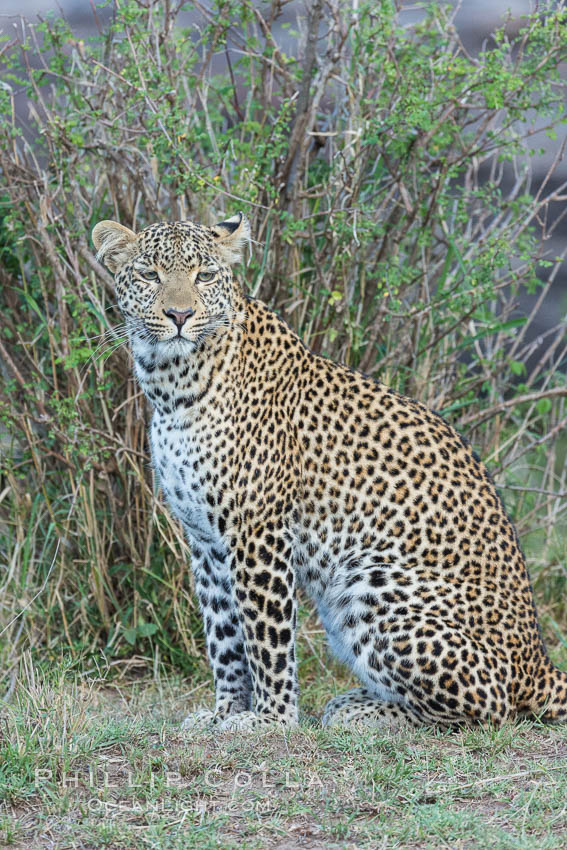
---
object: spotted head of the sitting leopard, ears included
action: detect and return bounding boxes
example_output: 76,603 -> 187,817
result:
92,213 -> 250,350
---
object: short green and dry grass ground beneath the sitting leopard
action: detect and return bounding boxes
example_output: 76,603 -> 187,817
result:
0,618 -> 567,850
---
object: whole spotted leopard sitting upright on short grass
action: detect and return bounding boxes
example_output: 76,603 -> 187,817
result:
92,213 -> 567,732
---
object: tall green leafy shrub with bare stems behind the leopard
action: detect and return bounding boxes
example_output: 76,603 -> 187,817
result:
0,0 -> 567,673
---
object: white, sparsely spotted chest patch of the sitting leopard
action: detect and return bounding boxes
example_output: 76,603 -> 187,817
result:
150,415 -> 224,549
